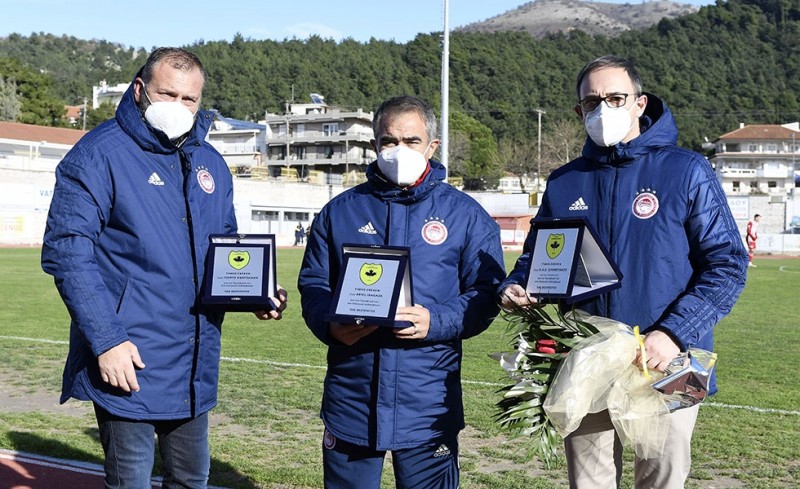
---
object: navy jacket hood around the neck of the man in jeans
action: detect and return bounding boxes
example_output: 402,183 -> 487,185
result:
115,69 -> 214,153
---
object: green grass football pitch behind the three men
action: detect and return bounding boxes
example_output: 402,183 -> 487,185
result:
0,248 -> 800,489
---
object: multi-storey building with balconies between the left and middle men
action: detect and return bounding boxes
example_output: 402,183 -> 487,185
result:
262,94 -> 376,186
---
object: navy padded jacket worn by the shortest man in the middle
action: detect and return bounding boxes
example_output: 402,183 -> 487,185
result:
298,162 -> 505,450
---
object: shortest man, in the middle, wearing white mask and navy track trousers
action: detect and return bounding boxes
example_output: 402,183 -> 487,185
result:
298,96 -> 505,489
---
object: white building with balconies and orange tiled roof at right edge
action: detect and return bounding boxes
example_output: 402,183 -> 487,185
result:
709,122 -> 800,198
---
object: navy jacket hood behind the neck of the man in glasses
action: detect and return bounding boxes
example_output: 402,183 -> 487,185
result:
583,92 -> 678,165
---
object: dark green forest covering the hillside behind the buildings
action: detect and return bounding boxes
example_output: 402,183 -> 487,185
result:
0,0 -> 800,186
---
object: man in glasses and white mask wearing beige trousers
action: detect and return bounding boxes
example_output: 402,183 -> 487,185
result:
499,56 -> 747,489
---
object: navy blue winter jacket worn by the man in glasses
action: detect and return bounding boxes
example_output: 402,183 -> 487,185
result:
501,94 -> 747,393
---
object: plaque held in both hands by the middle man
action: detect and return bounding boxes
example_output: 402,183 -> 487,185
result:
326,244 -> 414,328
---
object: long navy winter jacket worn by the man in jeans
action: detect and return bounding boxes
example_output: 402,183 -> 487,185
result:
42,77 -> 236,420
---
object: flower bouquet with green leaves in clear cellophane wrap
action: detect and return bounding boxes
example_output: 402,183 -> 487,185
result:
497,307 -> 716,466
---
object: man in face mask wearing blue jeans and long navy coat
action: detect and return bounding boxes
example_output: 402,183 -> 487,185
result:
42,48 -> 286,489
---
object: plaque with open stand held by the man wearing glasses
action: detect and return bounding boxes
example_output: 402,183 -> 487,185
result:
525,219 -> 622,303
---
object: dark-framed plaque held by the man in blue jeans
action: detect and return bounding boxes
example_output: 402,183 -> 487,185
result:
203,234 -> 278,311
